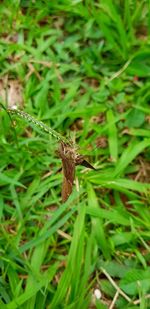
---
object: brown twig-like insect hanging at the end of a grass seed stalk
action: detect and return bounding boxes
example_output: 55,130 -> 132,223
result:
58,142 -> 95,202
